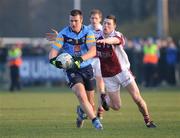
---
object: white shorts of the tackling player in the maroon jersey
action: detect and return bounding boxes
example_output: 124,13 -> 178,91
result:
103,70 -> 134,92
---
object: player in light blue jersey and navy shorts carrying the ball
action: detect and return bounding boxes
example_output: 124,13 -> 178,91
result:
49,9 -> 103,130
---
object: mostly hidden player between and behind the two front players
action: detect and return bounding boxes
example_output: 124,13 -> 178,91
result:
88,9 -> 105,119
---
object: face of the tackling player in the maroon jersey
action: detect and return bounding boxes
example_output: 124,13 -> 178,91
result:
103,18 -> 116,35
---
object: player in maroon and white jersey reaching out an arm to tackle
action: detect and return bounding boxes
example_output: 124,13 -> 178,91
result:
96,15 -> 156,128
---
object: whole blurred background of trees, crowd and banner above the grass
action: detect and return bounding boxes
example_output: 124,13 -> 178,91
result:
0,0 -> 180,89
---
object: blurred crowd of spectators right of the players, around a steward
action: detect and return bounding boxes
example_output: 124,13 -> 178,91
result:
125,37 -> 180,87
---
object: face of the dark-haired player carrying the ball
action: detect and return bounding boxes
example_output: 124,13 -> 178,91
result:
69,15 -> 83,33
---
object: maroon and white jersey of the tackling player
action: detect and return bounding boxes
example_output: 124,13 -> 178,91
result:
96,31 -> 130,77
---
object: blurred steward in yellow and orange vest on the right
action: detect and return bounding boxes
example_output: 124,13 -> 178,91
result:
143,38 -> 159,87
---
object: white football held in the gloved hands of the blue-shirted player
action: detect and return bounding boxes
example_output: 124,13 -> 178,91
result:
56,53 -> 73,69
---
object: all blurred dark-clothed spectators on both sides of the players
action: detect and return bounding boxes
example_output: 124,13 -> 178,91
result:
0,37 -> 180,87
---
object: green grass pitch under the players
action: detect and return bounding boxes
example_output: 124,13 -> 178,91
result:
0,87 -> 180,138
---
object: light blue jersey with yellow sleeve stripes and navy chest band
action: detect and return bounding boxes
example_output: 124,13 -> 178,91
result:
52,25 -> 96,68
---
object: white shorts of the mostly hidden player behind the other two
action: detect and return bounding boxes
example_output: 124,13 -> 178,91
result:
91,57 -> 102,77
